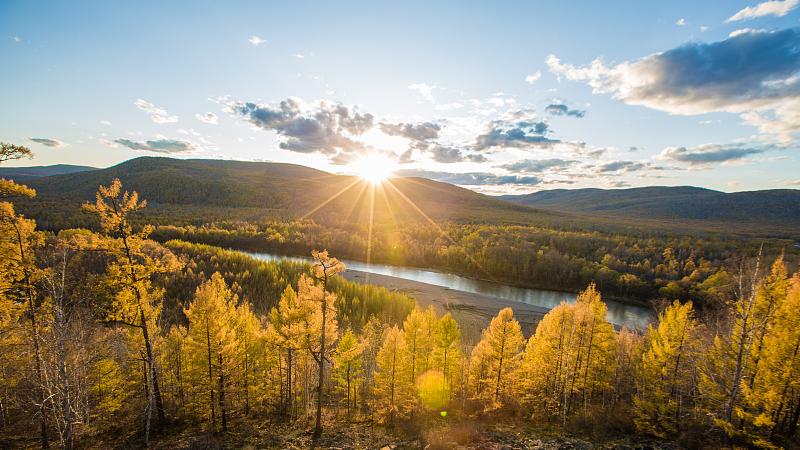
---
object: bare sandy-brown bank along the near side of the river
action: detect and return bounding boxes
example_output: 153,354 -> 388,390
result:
342,269 -> 549,344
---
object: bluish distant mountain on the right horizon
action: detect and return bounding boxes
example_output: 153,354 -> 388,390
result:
500,186 -> 800,230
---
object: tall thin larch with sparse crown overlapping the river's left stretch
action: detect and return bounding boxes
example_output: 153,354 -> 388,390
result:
311,250 -> 345,438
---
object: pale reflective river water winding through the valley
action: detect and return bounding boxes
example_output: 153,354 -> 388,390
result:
243,252 -> 653,329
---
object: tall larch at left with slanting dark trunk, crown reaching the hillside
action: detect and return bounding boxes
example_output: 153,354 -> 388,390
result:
83,179 -> 180,440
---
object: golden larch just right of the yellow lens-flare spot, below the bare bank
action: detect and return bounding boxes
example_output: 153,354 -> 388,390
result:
473,308 -> 525,408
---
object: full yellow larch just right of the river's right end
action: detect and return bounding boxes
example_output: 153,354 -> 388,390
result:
634,301 -> 700,438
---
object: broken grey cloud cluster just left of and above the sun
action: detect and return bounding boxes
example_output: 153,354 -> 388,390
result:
227,98 -> 374,161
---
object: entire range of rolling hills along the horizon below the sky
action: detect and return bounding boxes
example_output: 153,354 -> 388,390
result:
9,157 -> 800,240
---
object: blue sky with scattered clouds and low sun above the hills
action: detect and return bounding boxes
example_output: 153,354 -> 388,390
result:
0,0 -> 800,194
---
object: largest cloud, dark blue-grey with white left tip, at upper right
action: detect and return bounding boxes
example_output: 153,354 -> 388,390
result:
547,28 -> 800,140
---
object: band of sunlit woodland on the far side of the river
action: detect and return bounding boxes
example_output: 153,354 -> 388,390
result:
153,220 -> 798,308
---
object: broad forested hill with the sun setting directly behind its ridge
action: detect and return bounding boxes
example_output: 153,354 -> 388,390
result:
19,157 -> 563,228
